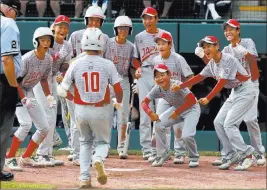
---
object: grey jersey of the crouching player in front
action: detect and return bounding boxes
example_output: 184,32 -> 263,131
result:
147,80 -> 191,108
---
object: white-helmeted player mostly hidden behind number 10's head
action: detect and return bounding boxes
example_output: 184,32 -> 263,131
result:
69,6 -> 109,57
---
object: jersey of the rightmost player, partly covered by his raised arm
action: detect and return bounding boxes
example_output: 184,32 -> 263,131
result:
222,38 -> 258,76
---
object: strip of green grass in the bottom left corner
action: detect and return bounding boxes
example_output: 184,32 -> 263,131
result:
1,181 -> 56,189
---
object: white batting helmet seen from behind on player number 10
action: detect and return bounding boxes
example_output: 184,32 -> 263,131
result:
82,28 -> 105,51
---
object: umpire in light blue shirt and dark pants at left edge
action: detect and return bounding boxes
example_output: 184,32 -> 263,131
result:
0,0 -> 21,181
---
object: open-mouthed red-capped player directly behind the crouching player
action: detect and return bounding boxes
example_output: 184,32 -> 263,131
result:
148,32 -> 195,164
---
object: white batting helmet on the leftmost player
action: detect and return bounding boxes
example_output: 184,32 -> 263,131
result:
32,27 -> 54,49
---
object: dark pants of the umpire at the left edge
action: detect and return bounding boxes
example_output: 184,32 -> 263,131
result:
0,74 -> 18,171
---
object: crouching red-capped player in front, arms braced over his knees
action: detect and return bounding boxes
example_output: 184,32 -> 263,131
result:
141,64 -> 200,167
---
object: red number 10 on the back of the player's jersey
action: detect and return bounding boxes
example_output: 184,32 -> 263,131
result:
82,72 -> 100,92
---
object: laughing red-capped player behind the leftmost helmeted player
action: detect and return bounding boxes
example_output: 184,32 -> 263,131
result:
34,15 -> 72,165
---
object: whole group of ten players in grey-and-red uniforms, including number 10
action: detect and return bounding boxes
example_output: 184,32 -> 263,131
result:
3,3 -> 265,187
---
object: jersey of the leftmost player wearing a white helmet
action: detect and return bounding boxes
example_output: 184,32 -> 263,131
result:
20,50 -> 53,90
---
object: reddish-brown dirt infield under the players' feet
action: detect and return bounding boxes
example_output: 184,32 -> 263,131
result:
8,156 -> 266,189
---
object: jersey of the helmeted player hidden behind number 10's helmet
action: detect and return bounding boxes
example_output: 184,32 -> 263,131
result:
69,29 -> 109,57
